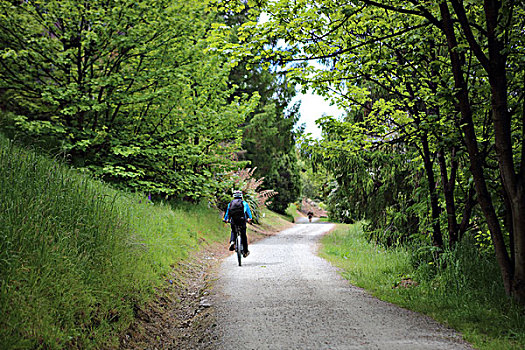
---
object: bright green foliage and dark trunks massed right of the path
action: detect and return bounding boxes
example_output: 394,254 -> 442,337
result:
219,0 -> 525,302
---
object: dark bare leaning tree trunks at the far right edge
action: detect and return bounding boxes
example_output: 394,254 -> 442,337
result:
434,0 -> 525,303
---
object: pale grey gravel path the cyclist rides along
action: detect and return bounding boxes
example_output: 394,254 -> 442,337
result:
213,223 -> 471,350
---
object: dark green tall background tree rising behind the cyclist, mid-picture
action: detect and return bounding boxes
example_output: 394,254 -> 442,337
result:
222,5 -> 301,213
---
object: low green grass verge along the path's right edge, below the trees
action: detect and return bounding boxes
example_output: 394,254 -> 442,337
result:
321,224 -> 525,350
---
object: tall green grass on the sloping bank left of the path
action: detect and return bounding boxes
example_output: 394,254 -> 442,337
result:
0,136 -> 227,349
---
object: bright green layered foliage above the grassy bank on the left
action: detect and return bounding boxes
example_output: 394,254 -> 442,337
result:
0,0 -> 257,199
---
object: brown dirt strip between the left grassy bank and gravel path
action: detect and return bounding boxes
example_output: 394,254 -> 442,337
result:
118,217 -> 293,350
